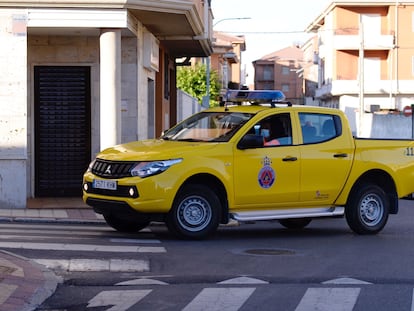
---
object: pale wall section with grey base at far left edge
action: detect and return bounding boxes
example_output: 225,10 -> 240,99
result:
0,9 -> 28,208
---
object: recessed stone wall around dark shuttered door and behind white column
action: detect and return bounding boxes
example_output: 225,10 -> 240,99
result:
24,26 -> 155,199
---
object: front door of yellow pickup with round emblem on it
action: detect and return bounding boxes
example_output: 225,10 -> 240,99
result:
234,113 -> 300,209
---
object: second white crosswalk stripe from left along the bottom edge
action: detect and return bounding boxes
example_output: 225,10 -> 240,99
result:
183,287 -> 255,311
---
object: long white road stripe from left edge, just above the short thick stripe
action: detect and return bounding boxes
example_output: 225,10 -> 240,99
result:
0,242 -> 166,253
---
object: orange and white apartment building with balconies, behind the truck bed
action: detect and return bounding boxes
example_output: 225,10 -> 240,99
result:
306,0 -> 414,137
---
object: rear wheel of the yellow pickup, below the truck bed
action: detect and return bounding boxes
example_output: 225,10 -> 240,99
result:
345,184 -> 389,234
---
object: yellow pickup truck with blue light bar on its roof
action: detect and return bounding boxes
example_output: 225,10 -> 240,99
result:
83,91 -> 414,239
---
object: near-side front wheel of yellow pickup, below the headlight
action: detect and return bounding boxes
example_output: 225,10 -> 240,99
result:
166,185 -> 221,239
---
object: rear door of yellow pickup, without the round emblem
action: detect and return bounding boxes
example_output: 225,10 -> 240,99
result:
299,113 -> 354,206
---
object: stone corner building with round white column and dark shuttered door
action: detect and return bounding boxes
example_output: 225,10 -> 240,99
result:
0,0 -> 212,208
